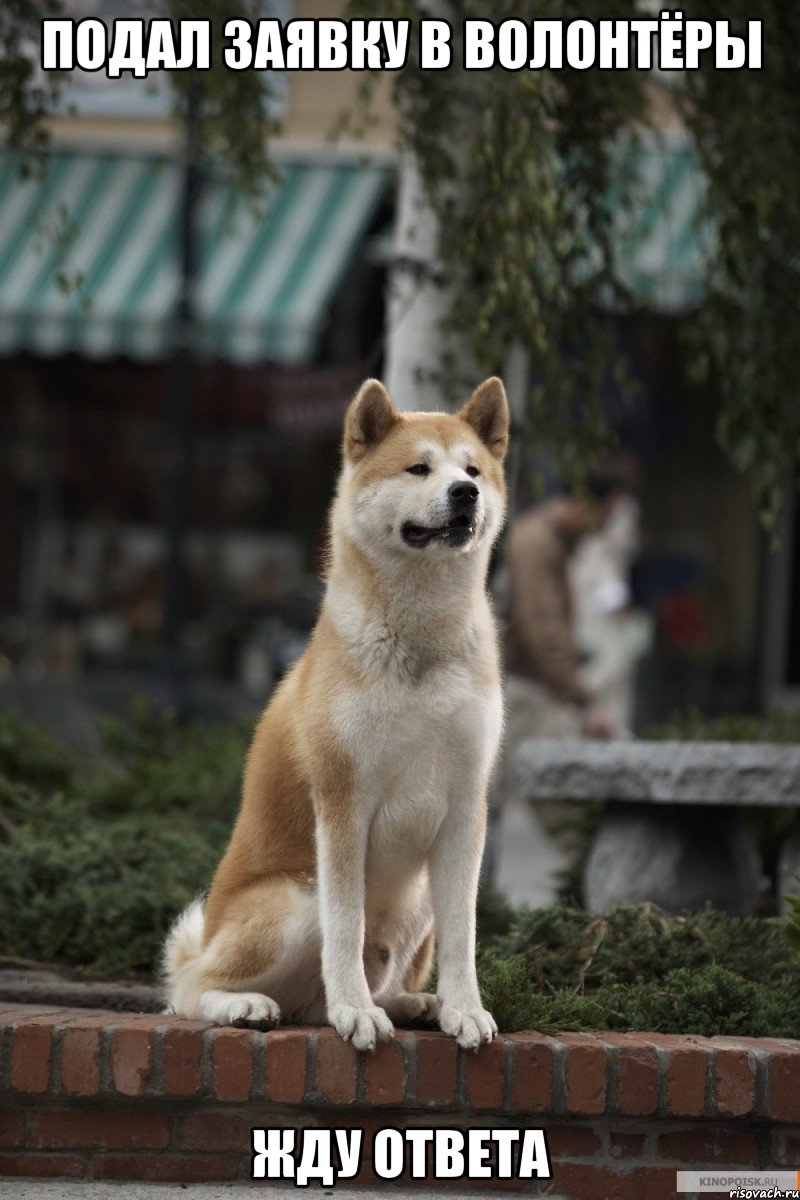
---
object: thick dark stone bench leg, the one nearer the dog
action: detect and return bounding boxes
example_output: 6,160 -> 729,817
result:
584,804 -> 767,916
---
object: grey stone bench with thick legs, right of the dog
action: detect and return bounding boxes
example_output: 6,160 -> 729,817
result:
517,740 -> 800,914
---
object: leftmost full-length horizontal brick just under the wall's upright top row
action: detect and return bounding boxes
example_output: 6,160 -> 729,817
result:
30,1109 -> 169,1150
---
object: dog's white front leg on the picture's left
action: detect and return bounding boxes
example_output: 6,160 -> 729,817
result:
317,810 -> 393,1050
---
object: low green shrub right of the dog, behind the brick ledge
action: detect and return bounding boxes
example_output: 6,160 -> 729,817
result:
479,905 -> 800,1037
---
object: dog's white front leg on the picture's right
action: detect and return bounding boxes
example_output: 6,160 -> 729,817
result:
428,794 -> 498,1050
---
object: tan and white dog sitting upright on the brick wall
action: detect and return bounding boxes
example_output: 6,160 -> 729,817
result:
164,379 -> 509,1050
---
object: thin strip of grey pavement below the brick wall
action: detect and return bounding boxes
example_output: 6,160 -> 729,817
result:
0,1180 -> 564,1200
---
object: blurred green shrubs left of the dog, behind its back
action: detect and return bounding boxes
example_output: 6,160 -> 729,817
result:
0,702 -> 247,973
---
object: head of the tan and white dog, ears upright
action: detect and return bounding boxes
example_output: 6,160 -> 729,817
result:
339,378 -> 509,558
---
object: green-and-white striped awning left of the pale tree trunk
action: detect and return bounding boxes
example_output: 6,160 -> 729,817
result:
0,152 -> 387,362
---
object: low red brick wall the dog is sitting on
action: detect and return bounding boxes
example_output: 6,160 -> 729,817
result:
0,1004 -> 800,1200
